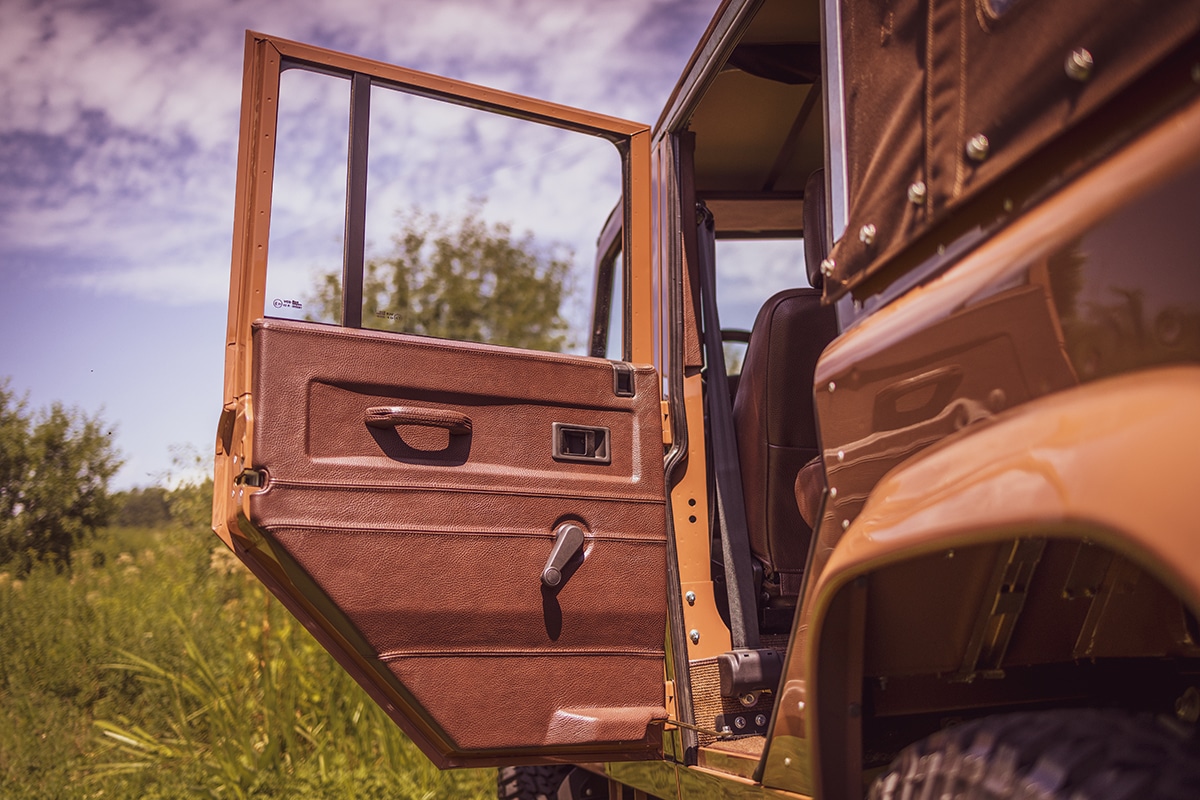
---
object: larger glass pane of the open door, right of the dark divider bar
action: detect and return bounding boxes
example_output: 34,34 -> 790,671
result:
362,86 -> 622,354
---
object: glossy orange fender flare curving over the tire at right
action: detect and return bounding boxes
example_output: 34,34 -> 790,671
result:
814,366 -> 1200,609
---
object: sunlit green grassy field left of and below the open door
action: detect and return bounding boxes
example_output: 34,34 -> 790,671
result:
0,525 -> 496,799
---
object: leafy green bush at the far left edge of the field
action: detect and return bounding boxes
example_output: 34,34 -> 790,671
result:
0,380 -> 121,572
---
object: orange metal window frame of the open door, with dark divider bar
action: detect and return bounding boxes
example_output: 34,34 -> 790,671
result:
222,31 -> 654,545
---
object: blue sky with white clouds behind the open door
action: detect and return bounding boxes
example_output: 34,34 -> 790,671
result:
0,0 -> 719,489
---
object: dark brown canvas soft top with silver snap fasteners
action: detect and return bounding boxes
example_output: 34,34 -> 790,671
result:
826,0 -> 1200,303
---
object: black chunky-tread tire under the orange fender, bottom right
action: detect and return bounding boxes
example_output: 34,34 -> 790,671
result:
869,709 -> 1200,800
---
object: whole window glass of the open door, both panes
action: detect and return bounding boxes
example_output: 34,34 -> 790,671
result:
266,70 -> 623,354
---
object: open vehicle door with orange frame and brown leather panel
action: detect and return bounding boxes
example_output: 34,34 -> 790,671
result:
214,34 -> 667,768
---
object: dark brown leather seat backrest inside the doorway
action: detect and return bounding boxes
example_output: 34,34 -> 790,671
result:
733,289 -> 838,595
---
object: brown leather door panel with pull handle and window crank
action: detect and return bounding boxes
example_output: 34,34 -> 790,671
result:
248,320 -> 666,765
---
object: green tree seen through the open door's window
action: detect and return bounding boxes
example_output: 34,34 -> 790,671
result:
308,207 -> 570,351
